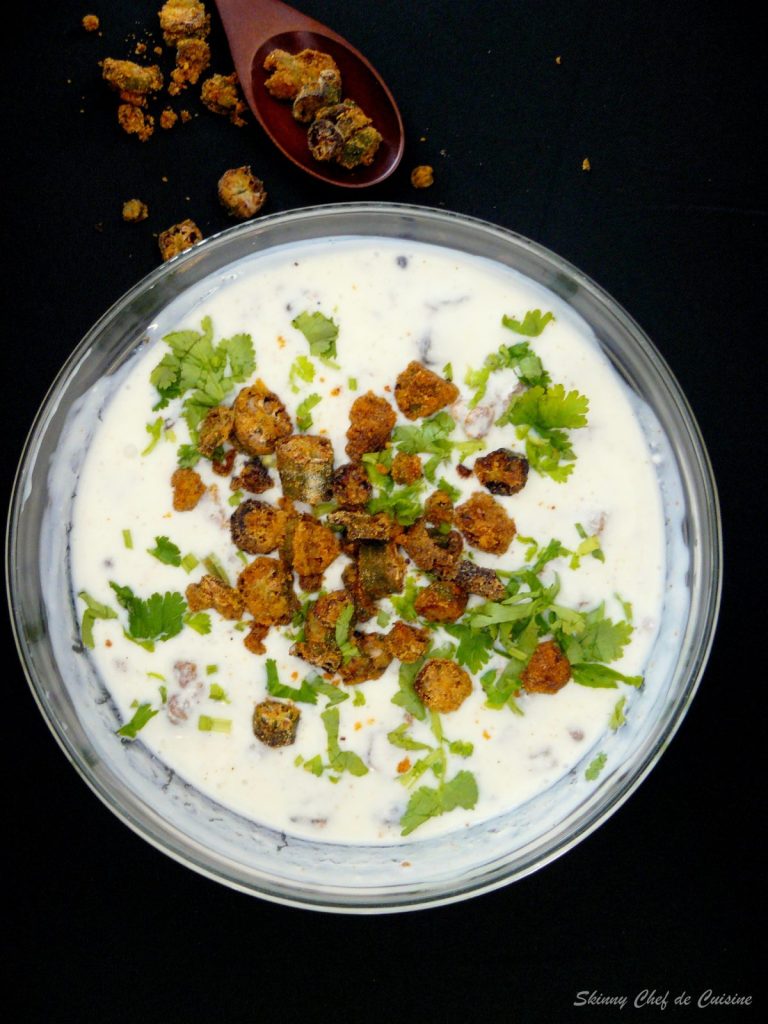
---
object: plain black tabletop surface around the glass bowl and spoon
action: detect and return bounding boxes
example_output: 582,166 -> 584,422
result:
2,0 -> 766,1022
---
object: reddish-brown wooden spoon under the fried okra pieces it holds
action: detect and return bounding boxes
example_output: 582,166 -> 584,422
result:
216,0 -> 404,188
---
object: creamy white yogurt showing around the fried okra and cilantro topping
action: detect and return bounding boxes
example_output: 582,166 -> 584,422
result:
71,240 -> 665,844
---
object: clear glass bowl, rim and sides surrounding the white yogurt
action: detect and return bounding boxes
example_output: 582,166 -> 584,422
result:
7,203 -> 721,912
